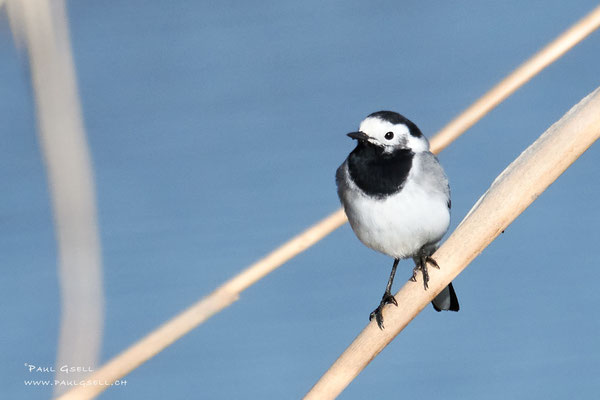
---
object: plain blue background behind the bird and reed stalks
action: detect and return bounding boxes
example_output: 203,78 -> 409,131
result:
0,0 -> 600,399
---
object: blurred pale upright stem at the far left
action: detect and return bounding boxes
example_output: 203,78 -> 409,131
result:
7,0 -> 104,392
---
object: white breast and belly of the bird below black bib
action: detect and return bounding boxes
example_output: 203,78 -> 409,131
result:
343,158 -> 450,258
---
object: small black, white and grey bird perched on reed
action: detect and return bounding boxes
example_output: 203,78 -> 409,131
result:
336,111 -> 460,329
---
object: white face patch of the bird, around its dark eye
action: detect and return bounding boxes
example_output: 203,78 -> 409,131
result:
359,117 -> 429,153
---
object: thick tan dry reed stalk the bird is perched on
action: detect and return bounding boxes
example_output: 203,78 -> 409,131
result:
305,88 -> 600,400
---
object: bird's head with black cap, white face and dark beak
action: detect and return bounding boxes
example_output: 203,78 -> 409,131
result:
348,111 -> 429,153
